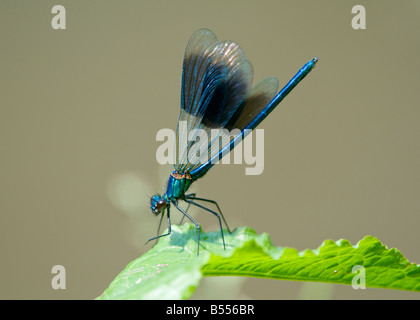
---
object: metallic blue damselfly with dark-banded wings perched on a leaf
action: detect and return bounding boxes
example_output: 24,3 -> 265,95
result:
147,29 -> 318,255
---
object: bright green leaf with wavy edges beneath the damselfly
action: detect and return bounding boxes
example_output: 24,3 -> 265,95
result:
97,224 -> 420,299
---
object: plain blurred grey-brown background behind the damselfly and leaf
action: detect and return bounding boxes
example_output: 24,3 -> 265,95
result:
0,0 -> 420,299
